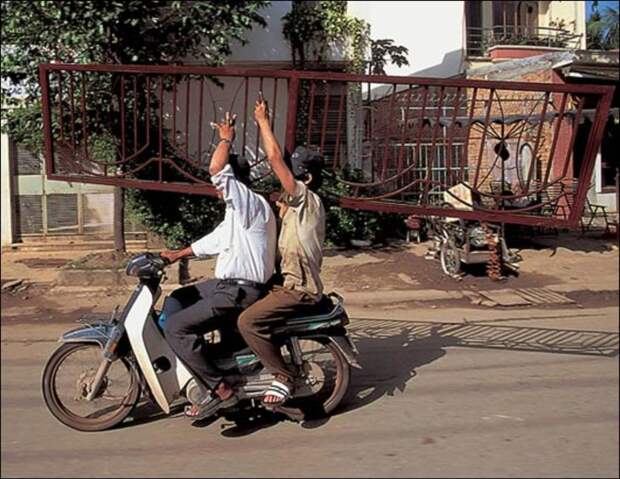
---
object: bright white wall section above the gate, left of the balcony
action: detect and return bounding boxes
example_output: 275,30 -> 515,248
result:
347,1 -> 465,77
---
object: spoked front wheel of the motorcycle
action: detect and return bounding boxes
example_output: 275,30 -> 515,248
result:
42,343 -> 140,431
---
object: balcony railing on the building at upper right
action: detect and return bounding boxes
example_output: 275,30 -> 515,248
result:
467,25 -> 581,57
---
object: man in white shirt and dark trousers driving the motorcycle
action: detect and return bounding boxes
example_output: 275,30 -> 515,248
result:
161,112 -> 276,419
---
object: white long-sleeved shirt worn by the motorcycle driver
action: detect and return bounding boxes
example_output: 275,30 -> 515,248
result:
191,165 -> 276,283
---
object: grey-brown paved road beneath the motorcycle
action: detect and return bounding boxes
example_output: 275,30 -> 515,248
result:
2,308 -> 619,477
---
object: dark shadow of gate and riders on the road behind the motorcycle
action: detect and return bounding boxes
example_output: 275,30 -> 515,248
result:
338,319 -> 619,413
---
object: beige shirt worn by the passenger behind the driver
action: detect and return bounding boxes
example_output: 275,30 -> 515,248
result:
278,181 -> 325,299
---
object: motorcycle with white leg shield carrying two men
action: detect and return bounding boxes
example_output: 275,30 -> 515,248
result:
42,253 -> 360,431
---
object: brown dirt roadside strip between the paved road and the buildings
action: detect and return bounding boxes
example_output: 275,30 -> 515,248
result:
1,232 -> 619,324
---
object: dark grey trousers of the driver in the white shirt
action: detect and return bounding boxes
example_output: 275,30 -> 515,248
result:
164,279 -> 261,389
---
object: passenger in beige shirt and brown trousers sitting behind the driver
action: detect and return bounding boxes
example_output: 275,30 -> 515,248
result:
238,100 -> 325,408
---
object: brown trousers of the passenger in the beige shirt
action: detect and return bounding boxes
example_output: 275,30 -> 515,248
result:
237,286 -> 317,383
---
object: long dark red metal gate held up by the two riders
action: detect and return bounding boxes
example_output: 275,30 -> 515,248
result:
40,64 -> 613,227
